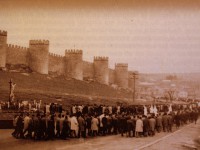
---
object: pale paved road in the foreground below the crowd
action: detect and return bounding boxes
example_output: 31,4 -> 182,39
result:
0,122 -> 200,150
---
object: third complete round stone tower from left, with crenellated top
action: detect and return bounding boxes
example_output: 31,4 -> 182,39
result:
94,57 -> 109,85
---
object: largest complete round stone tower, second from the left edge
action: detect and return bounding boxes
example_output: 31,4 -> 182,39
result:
29,40 -> 49,74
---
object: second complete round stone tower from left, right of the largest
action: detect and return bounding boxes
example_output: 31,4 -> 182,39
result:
65,50 -> 83,80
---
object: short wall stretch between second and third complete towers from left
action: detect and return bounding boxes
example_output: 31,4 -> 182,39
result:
83,61 -> 94,79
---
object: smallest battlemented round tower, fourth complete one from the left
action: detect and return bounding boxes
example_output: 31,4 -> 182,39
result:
115,63 -> 128,88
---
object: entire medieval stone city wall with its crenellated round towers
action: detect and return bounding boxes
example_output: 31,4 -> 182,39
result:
0,28 -> 139,89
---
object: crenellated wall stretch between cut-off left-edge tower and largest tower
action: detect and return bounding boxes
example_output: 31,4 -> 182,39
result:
6,44 -> 28,66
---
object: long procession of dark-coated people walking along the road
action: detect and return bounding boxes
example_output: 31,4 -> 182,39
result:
12,105 -> 200,140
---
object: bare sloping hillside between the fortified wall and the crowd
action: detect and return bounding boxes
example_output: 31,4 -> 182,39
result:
0,71 -> 132,105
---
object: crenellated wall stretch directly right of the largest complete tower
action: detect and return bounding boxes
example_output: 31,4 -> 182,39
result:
48,53 -> 65,75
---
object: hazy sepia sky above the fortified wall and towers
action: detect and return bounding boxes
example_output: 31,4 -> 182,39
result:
0,0 -> 200,73
